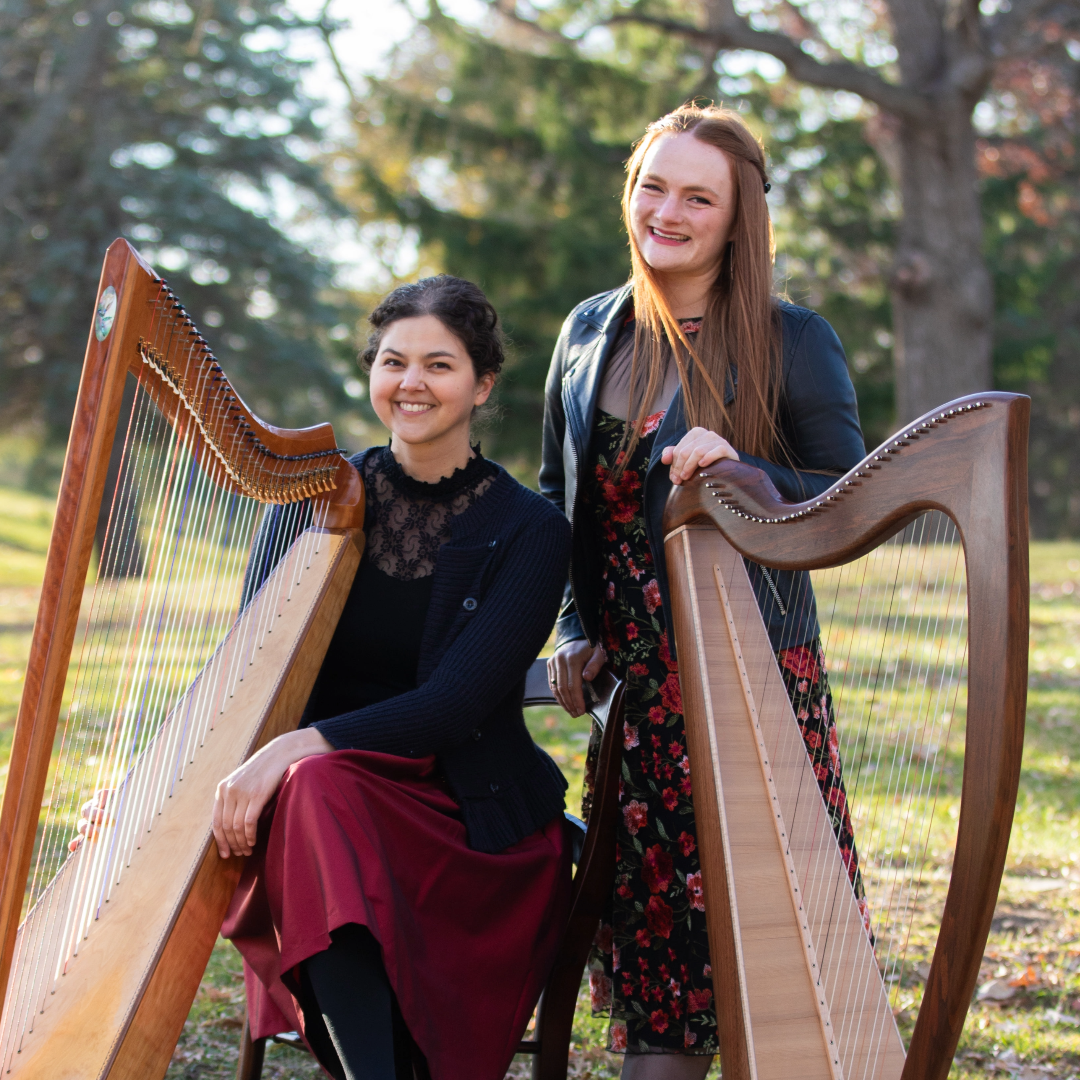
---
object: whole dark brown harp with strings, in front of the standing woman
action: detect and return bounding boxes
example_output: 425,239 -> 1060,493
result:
664,393 -> 1029,1080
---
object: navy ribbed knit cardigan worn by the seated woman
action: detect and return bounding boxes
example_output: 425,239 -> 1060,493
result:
245,451 -> 570,852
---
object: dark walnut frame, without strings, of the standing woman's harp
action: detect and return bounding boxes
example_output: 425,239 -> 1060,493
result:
664,392 -> 1029,1080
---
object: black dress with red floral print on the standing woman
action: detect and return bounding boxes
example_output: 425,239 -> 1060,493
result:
583,411 -> 862,1055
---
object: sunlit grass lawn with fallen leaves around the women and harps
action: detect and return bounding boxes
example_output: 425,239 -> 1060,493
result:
0,488 -> 1080,1080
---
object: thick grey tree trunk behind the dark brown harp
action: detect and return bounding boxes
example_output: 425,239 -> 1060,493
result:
891,95 -> 994,423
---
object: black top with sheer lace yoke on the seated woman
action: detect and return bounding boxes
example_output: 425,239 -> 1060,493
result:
308,447 -> 498,723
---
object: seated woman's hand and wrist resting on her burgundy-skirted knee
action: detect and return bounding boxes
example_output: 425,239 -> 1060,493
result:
214,728 -> 334,859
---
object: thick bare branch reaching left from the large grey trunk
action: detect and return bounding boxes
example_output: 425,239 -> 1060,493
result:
598,13 -> 930,120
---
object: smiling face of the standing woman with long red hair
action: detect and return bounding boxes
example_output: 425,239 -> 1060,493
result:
630,132 -> 735,281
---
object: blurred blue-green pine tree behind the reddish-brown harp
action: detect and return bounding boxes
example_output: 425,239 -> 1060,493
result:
0,0 -> 358,484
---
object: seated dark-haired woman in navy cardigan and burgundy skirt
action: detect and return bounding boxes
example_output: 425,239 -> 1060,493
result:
214,276 -> 570,1080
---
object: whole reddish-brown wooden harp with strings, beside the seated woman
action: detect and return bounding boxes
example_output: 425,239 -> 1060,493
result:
0,240 -> 364,1080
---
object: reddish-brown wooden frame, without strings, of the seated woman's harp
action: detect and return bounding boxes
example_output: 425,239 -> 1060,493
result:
0,240 -> 364,1080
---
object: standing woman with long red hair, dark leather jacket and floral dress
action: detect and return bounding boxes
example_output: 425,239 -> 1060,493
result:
540,107 -> 864,1080
